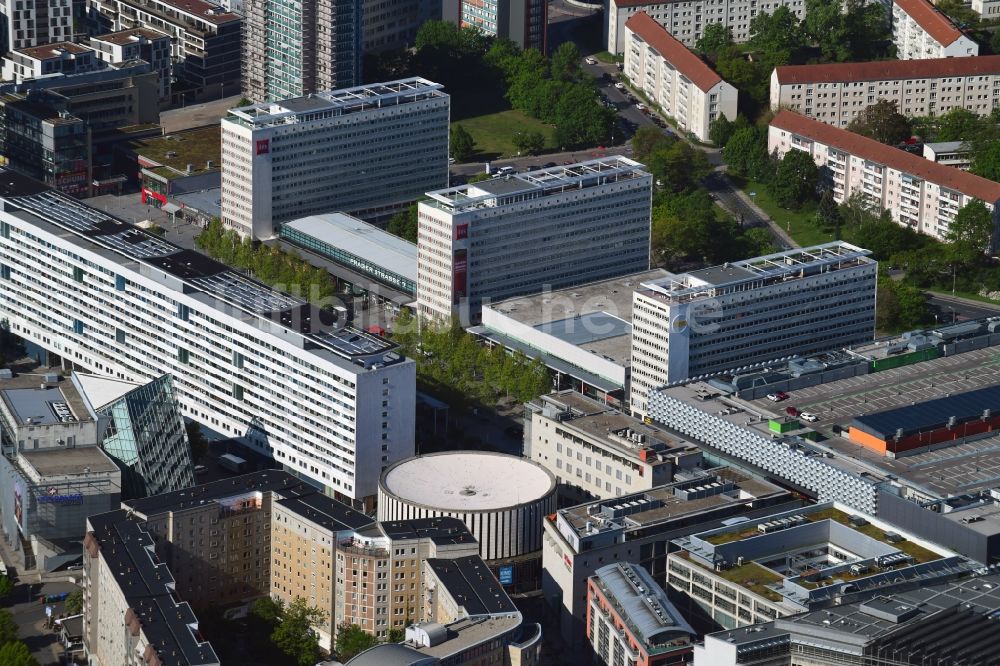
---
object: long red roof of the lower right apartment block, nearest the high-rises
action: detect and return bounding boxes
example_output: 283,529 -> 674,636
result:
771,110 -> 1000,204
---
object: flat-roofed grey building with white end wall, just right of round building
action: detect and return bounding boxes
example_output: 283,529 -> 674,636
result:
542,467 -> 805,652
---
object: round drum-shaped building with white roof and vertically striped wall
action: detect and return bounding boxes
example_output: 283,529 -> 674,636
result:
378,451 -> 556,582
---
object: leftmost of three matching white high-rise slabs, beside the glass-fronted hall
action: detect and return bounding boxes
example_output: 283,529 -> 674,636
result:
222,78 -> 451,238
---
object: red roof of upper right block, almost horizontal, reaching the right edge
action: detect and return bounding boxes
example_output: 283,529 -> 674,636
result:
775,55 -> 1000,85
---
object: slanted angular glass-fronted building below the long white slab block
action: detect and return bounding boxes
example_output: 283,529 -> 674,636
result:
96,375 -> 194,499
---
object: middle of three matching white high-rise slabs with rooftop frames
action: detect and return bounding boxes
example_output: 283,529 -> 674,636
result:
417,157 -> 652,322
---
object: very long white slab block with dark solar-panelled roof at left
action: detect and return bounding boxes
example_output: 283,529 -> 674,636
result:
0,171 -> 415,500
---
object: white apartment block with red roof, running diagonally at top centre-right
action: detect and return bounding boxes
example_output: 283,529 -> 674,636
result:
625,12 -> 738,142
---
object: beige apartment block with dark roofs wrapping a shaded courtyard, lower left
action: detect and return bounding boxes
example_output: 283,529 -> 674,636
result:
123,470 -> 373,640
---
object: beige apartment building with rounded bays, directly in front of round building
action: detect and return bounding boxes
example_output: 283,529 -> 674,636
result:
334,517 -> 479,640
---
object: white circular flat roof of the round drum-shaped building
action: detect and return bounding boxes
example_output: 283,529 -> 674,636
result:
383,451 -> 555,511
